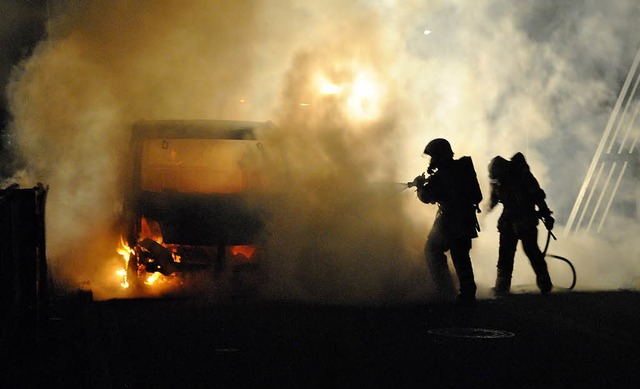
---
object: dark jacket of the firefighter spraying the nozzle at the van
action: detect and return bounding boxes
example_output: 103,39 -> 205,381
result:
417,157 -> 482,238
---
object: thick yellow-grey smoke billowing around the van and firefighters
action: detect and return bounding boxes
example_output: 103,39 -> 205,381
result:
8,0 -> 640,302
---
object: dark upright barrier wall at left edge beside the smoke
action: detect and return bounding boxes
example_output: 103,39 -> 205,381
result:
0,184 -> 48,345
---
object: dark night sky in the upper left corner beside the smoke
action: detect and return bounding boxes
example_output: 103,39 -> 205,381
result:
0,0 -> 46,178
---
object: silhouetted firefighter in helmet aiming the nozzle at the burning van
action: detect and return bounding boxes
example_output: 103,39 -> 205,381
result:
410,138 -> 482,305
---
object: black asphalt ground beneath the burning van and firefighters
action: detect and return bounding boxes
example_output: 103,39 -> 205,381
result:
3,291 -> 640,388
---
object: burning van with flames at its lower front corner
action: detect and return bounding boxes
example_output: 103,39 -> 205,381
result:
119,120 -> 270,288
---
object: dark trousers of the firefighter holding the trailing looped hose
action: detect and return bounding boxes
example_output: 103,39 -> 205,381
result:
495,223 -> 552,293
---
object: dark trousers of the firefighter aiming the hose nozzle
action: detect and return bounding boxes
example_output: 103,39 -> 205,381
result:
424,219 -> 476,300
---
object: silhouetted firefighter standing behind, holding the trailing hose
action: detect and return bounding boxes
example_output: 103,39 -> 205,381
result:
489,153 -> 554,295
